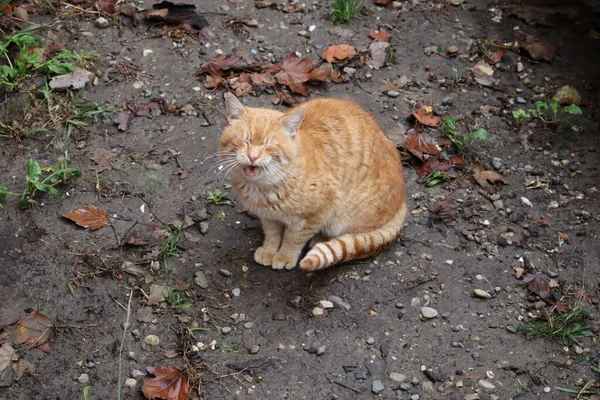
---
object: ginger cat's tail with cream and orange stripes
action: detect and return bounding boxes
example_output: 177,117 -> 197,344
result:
300,204 -> 407,271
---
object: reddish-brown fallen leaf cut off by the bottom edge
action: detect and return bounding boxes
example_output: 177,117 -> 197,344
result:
142,365 -> 190,400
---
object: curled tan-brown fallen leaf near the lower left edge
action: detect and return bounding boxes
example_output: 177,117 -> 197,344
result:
4,311 -> 54,347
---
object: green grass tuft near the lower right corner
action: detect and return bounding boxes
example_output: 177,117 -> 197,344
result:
521,307 -> 595,344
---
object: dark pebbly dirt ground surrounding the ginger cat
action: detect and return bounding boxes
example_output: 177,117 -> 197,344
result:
0,0 -> 600,400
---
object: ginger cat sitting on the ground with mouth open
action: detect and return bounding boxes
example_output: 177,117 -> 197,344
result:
219,93 -> 407,271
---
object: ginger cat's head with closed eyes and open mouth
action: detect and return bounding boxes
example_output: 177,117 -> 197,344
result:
221,93 -> 305,185
